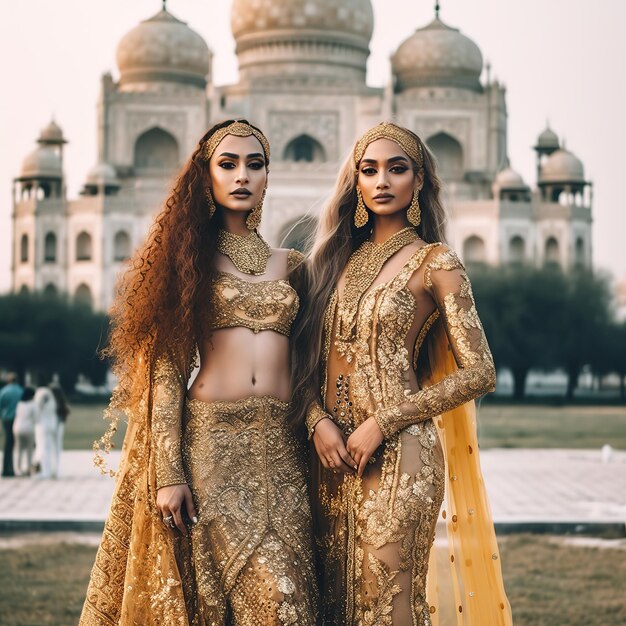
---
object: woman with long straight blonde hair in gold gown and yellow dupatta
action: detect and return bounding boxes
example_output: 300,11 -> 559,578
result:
293,124 -> 511,626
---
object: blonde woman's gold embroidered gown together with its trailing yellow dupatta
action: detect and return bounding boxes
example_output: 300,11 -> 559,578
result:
307,244 -> 511,626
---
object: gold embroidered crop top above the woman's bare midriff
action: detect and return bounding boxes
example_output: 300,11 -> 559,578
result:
211,250 -> 304,337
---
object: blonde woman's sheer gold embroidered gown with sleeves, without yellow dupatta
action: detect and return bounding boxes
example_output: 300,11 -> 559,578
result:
307,244 -> 508,626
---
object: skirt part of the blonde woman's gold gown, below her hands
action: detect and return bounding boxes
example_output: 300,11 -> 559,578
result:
312,420 -> 444,626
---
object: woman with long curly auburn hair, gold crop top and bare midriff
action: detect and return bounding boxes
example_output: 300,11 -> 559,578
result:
80,120 -> 317,626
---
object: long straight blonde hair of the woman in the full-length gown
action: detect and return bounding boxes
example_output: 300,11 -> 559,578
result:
290,128 -> 446,427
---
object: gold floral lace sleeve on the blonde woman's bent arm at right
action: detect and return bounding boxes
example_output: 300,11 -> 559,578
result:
374,248 -> 496,438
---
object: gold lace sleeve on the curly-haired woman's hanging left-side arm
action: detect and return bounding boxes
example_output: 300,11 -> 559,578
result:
152,357 -> 187,489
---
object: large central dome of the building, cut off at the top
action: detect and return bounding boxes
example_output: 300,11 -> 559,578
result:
231,0 -> 374,84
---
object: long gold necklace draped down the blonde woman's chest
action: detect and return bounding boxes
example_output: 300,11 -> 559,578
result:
336,226 -> 419,354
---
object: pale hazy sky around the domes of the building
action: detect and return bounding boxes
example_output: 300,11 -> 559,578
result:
0,0 -> 626,292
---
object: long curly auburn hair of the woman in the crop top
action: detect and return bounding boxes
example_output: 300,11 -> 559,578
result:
103,120 -> 268,408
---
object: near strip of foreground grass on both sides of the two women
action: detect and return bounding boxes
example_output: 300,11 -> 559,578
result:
0,535 -> 626,626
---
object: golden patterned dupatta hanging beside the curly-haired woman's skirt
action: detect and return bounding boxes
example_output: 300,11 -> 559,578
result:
79,356 -> 196,626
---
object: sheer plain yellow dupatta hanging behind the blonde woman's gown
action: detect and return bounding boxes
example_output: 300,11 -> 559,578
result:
419,320 -> 513,626
